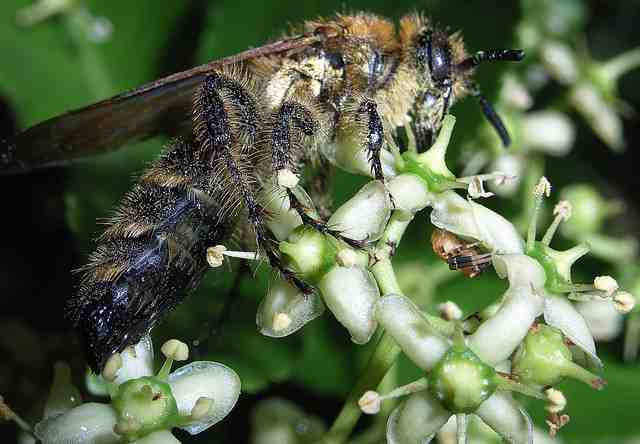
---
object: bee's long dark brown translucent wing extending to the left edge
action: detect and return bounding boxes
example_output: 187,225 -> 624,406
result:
0,33 -> 327,175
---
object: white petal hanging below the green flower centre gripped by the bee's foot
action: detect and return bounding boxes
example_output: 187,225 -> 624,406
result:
318,266 -> 380,344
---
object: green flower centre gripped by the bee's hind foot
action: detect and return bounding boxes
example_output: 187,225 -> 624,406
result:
280,226 -> 337,284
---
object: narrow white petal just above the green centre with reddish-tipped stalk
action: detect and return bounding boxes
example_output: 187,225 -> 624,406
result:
544,293 -> 602,368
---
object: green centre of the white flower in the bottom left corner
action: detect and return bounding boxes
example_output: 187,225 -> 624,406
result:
112,376 -> 179,441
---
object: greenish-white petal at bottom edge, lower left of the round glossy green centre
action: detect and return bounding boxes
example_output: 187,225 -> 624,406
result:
387,391 -> 451,444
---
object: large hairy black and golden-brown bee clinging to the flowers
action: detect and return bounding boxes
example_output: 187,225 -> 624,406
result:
0,13 -> 524,370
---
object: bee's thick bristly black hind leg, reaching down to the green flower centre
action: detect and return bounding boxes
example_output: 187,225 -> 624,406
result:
194,72 -> 312,293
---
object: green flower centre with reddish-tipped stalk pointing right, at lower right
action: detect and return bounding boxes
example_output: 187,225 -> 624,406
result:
511,325 -> 604,388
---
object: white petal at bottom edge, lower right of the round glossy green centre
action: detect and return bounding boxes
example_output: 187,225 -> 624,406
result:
475,393 -> 533,444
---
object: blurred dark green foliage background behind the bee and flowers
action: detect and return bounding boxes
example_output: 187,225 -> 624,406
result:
0,0 -> 640,443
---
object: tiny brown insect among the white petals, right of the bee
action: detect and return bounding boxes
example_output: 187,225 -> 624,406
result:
431,228 -> 491,278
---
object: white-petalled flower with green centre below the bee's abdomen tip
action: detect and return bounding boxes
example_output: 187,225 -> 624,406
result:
13,336 -> 240,444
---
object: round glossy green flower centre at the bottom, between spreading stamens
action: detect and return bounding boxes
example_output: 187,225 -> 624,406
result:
428,345 -> 498,413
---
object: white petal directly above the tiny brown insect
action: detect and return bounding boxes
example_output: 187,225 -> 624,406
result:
431,191 -> 524,254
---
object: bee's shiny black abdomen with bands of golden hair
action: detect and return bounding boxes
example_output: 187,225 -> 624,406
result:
69,142 -> 230,371
